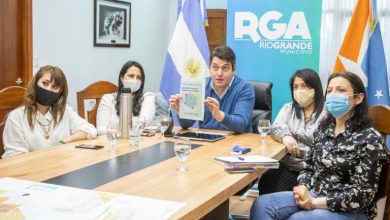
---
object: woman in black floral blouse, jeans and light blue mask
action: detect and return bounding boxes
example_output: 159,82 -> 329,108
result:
251,72 -> 387,220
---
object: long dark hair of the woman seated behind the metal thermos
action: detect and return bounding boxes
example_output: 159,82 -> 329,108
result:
115,60 -> 145,116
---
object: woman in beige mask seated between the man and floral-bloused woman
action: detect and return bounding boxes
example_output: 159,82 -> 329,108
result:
259,69 -> 325,195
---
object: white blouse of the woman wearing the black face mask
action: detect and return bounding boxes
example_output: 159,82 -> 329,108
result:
2,105 -> 96,158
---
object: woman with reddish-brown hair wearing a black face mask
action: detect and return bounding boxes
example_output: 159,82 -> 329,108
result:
2,65 -> 96,158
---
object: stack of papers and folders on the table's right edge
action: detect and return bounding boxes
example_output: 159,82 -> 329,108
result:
214,155 -> 279,169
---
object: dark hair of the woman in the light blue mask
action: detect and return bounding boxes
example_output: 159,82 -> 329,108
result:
320,72 -> 371,131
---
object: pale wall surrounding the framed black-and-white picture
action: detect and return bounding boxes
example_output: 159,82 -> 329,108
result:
33,0 -> 177,109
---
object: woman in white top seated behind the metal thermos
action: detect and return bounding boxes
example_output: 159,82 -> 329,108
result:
96,61 -> 156,135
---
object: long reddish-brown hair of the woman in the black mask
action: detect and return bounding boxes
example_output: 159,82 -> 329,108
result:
23,65 -> 68,129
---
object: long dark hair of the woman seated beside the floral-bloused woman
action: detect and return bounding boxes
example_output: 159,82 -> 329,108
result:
290,68 -> 325,120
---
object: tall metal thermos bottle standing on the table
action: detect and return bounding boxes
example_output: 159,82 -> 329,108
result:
119,88 -> 133,139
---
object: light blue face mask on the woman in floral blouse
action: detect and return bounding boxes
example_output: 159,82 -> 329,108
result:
325,93 -> 353,118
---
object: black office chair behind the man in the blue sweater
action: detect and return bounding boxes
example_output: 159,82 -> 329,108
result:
249,81 -> 272,133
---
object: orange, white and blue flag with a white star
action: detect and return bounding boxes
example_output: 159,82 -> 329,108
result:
333,0 -> 390,106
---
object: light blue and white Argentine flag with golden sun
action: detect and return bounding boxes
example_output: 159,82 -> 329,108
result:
160,0 -> 210,100
